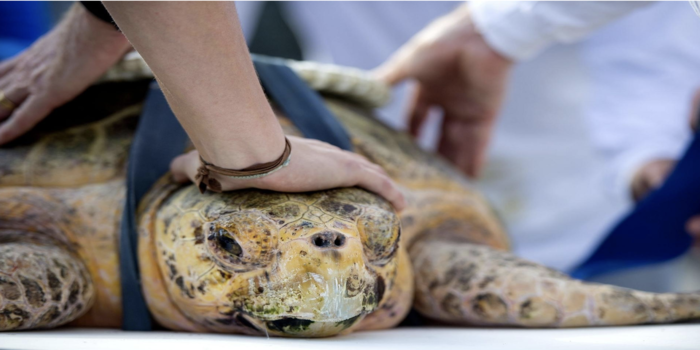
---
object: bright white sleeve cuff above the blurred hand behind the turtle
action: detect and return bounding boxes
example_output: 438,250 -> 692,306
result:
470,1 -> 650,61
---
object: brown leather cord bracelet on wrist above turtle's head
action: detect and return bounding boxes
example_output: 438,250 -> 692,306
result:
194,137 -> 292,193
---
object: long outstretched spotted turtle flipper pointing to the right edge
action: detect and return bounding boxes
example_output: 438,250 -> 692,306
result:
410,239 -> 700,327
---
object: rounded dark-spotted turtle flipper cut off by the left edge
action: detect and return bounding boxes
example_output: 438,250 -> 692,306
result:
0,239 -> 95,331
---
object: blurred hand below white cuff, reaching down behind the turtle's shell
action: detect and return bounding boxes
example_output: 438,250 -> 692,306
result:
375,6 -> 513,177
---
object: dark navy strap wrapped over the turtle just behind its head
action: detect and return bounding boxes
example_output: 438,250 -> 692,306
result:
119,56 -> 352,331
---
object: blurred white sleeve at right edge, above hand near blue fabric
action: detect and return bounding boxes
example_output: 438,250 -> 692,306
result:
577,2 -> 700,199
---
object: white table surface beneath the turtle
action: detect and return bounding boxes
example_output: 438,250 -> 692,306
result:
0,323 -> 700,350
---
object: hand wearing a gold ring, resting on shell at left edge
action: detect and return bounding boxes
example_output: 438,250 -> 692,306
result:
0,4 -> 131,145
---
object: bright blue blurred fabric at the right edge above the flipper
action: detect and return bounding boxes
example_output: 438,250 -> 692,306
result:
572,123 -> 700,279
